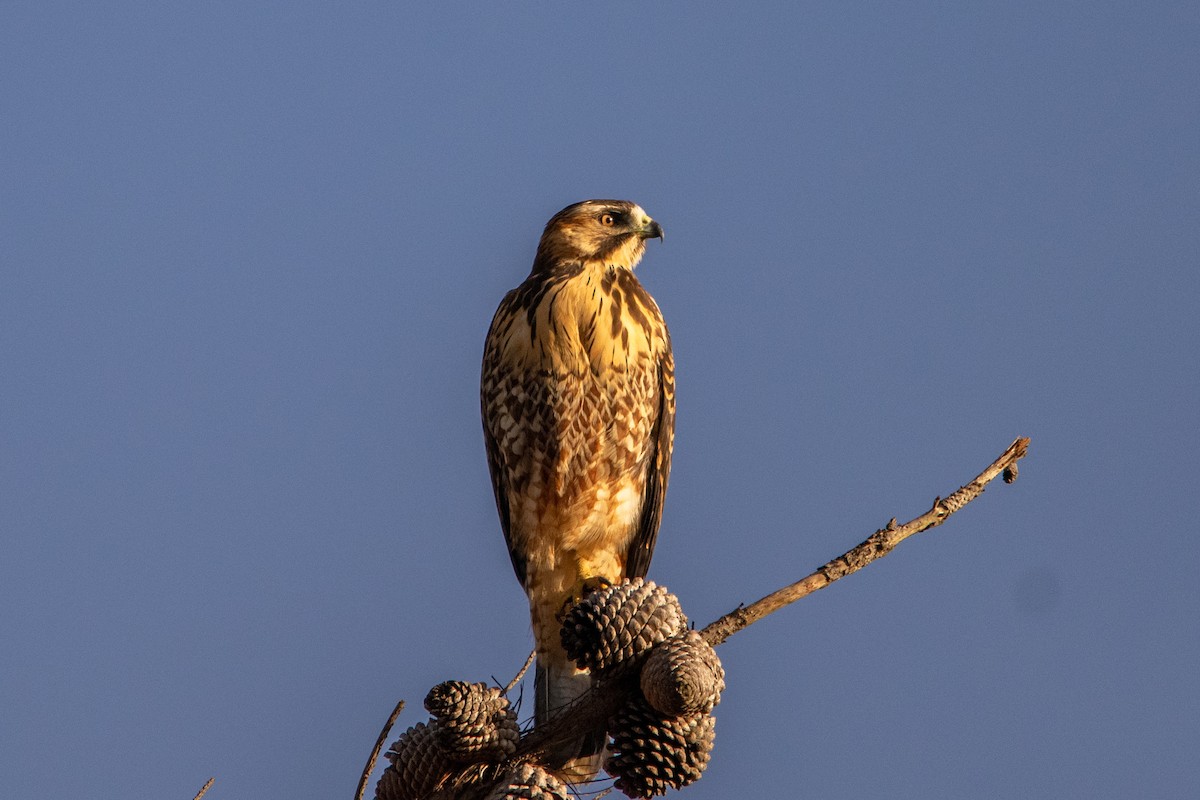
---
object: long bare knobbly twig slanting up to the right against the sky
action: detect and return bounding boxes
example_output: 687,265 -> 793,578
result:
701,438 -> 1030,646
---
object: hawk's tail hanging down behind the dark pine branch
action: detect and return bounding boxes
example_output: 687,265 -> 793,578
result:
534,652 -> 607,783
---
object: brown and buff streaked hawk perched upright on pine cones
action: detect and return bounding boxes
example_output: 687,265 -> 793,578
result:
480,200 -> 674,782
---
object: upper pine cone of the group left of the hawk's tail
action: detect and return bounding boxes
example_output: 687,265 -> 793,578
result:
425,680 -> 521,763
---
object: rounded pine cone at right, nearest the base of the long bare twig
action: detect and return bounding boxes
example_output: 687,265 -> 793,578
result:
641,631 -> 725,717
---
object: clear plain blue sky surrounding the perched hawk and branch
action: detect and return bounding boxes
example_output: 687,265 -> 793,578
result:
0,0 -> 1200,800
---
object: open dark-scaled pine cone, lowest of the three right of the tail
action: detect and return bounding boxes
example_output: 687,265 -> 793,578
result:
605,702 -> 716,798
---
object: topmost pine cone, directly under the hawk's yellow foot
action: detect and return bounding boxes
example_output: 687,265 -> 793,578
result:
562,578 -> 688,675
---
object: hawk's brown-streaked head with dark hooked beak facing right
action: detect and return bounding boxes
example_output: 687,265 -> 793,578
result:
534,200 -> 662,271
